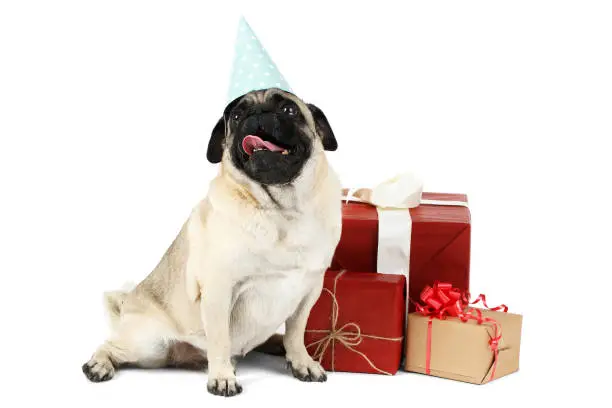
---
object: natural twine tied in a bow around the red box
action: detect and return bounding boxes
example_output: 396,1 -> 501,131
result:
306,271 -> 403,375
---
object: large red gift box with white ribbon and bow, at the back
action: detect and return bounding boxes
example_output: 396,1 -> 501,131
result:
331,174 -> 471,311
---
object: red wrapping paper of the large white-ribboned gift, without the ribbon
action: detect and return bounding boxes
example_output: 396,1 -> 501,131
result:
331,193 -> 471,312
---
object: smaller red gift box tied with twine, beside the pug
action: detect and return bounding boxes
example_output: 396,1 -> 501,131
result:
304,270 -> 406,375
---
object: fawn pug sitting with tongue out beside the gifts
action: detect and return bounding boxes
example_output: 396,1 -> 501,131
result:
82,88 -> 341,396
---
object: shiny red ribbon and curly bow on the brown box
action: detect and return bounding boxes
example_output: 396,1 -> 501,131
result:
413,282 -> 508,380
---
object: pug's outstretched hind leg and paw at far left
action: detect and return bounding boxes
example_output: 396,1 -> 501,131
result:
83,313 -> 175,382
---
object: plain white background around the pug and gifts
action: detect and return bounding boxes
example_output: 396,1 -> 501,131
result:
0,0 -> 612,407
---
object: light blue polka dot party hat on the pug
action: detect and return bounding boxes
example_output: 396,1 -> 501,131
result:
228,17 -> 292,102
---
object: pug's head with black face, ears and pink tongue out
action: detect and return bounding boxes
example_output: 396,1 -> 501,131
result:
207,88 -> 338,185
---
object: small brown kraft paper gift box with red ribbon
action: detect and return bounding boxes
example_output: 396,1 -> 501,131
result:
404,285 -> 522,384
